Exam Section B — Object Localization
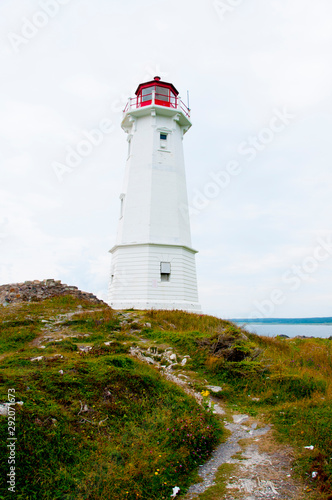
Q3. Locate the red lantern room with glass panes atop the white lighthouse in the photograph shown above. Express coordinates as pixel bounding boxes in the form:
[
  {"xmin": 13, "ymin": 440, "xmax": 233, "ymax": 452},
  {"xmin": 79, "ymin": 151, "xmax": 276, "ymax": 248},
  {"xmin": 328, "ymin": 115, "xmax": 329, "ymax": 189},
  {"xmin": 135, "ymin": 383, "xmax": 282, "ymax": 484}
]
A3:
[{"xmin": 135, "ymin": 76, "xmax": 179, "ymax": 108}]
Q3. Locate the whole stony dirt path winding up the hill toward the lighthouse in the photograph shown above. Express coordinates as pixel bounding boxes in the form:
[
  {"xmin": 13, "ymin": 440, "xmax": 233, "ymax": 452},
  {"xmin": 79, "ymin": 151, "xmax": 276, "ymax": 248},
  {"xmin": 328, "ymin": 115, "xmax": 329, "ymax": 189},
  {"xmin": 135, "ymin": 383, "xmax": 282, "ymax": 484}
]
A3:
[{"xmin": 131, "ymin": 342, "xmax": 317, "ymax": 500}]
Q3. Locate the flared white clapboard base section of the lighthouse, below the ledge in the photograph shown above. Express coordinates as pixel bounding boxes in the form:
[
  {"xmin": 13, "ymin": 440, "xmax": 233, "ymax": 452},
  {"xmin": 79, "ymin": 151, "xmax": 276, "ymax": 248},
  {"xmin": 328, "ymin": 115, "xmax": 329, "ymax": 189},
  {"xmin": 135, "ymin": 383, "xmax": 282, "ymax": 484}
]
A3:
[{"xmin": 108, "ymin": 243, "xmax": 201, "ymax": 312}]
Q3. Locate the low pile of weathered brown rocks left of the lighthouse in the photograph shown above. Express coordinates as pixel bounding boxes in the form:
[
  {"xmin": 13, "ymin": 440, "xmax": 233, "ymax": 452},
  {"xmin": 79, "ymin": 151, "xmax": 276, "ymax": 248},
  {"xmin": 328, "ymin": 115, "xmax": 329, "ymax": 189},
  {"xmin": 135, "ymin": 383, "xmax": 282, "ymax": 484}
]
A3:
[{"xmin": 0, "ymin": 279, "xmax": 105, "ymax": 305}]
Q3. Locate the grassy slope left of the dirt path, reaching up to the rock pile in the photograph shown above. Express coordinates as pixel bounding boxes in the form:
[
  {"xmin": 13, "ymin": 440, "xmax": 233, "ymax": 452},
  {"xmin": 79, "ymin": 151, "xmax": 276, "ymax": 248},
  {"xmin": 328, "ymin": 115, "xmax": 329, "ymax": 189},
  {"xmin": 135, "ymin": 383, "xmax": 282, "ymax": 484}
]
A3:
[{"xmin": 0, "ymin": 296, "xmax": 222, "ymax": 500}]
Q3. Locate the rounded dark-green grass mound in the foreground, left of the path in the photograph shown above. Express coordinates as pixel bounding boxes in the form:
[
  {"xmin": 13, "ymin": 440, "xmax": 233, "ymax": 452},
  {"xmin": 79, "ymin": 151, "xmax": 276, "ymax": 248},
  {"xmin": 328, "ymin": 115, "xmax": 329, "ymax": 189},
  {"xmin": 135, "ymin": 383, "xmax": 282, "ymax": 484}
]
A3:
[{"xmin": 1, "ymin": 355, "xmax": 223, "ymax": 499}]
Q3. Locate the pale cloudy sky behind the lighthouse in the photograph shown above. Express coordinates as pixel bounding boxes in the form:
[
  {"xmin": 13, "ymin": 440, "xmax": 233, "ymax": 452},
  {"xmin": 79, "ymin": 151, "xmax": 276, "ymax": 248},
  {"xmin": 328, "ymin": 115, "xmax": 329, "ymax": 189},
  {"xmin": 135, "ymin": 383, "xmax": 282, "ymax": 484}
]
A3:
[{"xmin": 0, "ymin": 0, "xmax": 332, "ymax": 318}]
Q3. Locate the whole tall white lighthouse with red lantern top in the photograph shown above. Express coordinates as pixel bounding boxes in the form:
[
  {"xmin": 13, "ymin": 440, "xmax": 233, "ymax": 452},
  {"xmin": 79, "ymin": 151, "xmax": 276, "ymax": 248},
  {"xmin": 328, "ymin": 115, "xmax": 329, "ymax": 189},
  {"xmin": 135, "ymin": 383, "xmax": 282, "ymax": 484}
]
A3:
[{"xmin": 109, "ymin": 76, "xmax": 200, "ymax": 312}]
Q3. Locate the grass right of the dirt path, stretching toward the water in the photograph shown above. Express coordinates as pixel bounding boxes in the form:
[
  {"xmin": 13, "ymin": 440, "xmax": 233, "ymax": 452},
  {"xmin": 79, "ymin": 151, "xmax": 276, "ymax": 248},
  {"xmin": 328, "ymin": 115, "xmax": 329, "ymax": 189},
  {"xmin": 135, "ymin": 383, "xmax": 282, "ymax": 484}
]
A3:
[{"xmin": 140, "ymin": 311, "xmax": 332, "ymax": 500}]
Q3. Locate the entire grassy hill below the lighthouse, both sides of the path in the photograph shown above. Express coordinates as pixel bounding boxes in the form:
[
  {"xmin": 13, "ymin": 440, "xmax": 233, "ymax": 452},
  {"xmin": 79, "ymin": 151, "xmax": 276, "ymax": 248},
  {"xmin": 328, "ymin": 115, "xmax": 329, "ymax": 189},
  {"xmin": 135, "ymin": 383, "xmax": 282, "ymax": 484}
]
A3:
[{"xmin": 0, "ymin": 295, "xmax": 332, "ymax": 500}]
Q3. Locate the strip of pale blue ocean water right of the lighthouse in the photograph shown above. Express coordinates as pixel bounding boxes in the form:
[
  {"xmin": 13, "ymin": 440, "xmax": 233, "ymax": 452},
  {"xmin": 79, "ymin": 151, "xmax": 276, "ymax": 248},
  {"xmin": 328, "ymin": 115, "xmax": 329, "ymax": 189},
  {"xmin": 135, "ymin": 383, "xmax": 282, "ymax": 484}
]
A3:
[{"xmin": 236, "ymin": 321, "xmax": 332, "ymax": 339}]
